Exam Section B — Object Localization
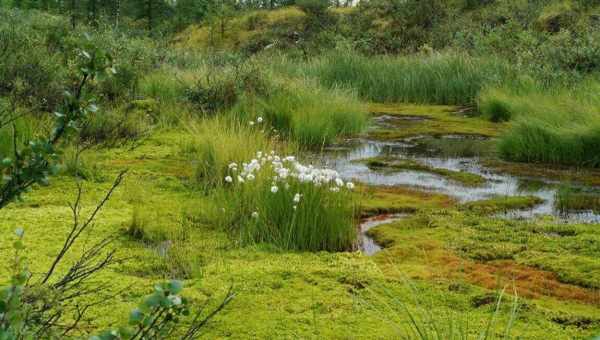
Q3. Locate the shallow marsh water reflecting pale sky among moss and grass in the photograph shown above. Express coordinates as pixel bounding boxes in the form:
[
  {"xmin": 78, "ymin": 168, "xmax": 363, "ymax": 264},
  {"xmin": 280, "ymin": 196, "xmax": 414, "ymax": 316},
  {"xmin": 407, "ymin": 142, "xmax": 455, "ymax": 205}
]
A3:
[{"xmin": 321, "ymin": 116, "xmax": 600, "ymax": 255}]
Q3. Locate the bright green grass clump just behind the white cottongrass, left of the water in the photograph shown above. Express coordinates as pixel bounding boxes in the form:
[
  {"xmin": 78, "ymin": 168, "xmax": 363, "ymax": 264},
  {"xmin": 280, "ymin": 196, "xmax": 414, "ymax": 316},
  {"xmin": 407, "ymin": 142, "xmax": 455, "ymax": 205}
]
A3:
[{"xmin": 232, "ymin": 80, "xmax": 368, "ymax": 148}]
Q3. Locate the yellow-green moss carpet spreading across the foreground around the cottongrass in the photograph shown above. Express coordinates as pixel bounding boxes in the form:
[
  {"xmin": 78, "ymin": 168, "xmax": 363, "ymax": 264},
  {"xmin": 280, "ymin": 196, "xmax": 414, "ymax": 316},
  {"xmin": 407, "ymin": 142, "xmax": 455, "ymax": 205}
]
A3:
[{"xmin": 0, "ymin": 116, "xmax": 600, "ymax": 338}]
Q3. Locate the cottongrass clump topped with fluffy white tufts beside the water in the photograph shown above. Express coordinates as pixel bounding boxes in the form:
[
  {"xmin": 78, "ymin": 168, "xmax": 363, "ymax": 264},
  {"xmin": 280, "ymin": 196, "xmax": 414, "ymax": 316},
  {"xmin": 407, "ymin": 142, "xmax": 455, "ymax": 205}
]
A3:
[{"xmin": 220, "ymin": 151, "xmax": 357, "ymax": 251}]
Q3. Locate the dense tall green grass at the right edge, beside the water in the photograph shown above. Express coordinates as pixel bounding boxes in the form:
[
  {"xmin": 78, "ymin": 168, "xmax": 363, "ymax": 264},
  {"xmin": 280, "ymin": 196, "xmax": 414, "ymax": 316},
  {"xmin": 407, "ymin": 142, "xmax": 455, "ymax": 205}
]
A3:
[{"xmin": 479, "ymin": 81, "xmax": 600, "ymax": 168}]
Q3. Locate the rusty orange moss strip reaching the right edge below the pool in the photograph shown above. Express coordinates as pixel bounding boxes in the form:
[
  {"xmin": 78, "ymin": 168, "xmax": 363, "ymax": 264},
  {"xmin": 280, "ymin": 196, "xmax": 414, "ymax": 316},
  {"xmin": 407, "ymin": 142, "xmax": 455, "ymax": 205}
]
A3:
[{"xmin": 379, "ymin": 239, "xmax": 600, "ymax": 305}]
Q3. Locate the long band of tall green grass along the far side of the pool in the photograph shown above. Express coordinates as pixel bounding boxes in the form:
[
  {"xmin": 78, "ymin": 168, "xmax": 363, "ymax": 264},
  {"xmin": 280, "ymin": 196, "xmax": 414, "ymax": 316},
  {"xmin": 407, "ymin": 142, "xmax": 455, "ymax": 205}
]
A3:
[{"xmin": 306, "ymin": 53, "xmax": 511, "ymax": 105}]
